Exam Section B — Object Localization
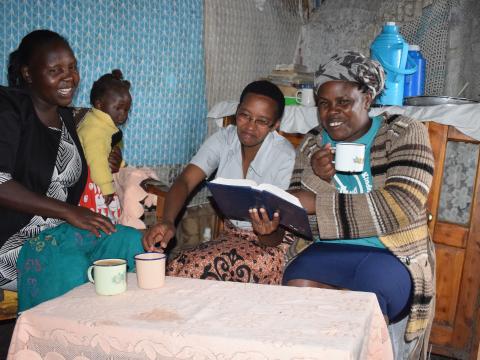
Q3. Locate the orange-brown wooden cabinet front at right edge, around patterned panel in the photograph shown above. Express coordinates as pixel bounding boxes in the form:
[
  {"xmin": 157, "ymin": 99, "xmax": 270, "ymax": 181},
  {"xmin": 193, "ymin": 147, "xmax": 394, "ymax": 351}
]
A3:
[{"xmin": 426, "ymin": 122, "xmax": 480, "ymax": 360}]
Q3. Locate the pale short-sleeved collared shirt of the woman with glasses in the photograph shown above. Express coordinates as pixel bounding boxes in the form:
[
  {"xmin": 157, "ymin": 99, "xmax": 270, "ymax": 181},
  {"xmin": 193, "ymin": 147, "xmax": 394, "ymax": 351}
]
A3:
[{"xmin": 190, "ymin": 125, "xmax": 295, "ymax": 228}]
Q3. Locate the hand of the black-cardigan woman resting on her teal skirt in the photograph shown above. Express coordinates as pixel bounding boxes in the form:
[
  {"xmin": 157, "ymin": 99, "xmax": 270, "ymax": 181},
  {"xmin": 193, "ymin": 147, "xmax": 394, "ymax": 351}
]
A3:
[{"xmin": 65, "ymin": 206, "xmax": 116, "ymax": 237}]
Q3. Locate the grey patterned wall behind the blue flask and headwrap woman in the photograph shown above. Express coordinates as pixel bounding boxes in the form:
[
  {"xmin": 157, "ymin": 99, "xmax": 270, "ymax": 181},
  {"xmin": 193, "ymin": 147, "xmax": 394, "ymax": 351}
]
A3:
[{"xmin": 301, "ymin": 0, "xmax": 452, "ymax": 95}]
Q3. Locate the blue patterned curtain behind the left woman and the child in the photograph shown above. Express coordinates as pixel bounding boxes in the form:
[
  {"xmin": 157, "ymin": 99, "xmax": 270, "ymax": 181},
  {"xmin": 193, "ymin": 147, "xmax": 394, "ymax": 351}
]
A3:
[{"xmin": 0, "ymin": 0, "xmax": 206, "ymax": 165}]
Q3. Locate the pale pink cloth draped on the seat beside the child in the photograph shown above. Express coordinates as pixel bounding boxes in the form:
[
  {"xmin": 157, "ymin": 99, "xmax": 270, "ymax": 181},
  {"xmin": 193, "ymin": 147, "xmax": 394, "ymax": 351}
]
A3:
[{"xmin": 113, "ymin": 166, "xmax": 158, "ymax": 229}]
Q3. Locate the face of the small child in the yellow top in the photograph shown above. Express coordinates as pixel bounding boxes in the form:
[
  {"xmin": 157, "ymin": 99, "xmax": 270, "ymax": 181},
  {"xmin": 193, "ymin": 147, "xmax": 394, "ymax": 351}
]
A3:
[{"xmin": 94, "ymin": 88, "xmax": 132, "ymax": 126}]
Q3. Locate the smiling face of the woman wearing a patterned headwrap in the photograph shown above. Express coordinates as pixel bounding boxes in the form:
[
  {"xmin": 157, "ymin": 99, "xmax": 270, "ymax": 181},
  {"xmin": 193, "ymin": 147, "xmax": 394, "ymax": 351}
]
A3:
[{"xmin": 317, "ymin": 81, "xmax": 372, "ymax": 141}]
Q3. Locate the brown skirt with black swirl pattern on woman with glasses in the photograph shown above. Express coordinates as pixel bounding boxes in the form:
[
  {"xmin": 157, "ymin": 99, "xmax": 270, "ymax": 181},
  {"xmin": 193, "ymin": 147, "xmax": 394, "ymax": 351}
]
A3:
[{"xmin": 167, "ymin": 222, "xmax": 292, "ymax": 285}]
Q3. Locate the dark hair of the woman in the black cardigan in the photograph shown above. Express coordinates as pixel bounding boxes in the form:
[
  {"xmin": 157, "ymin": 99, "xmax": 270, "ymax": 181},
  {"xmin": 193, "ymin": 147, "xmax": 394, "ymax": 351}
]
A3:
[{"xmin": 8, "ymin": 29, "xmax": 73, "ymax": 88}]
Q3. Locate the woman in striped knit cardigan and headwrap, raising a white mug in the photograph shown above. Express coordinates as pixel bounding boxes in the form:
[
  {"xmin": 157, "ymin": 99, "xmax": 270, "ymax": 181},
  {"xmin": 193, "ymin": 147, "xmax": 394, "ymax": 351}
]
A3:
[{"xmin": 252, "ymin": 51, "xmax": 435, "ymax": 359}]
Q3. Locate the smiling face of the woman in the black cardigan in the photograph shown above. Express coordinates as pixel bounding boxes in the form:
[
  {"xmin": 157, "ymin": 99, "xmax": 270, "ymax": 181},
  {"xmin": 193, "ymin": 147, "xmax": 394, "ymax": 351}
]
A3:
[{"xmin": 21, "ymin": 41, "xmax": 80, "ymax": 106}]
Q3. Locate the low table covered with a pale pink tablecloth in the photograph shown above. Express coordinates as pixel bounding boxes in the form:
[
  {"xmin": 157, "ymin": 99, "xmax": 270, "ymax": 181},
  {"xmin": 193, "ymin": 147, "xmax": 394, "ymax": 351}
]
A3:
[{"xmin": 8, "ymin": 274, "xmax": 393, "ymax": 360}]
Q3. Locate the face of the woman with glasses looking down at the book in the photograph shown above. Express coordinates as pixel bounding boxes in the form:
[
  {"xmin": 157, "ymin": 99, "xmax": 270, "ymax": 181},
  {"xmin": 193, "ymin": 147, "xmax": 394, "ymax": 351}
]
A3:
[{"xmin": 236, "ymin": 93, "xmax": 280, "ymax": 148}]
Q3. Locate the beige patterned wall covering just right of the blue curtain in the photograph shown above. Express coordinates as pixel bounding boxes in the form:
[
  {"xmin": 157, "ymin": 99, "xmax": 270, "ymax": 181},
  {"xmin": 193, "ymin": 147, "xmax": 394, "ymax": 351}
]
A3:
[{"xmin": 205, "ymin": 0, "xmax": 301, "ymax": 107}]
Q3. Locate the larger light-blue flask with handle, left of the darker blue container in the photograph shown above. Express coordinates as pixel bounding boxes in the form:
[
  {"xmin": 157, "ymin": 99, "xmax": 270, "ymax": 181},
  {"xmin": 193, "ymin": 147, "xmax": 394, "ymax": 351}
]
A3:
[{"xmin": 370, "ymin": 22, "xmax": 417, "ymax": 106}]
